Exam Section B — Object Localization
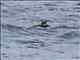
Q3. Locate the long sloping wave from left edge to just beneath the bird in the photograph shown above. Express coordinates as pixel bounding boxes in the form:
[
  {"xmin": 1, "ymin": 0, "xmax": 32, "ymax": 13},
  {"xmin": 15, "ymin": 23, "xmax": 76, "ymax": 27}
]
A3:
[{"xmin": 1, "ymin": 24, "xmax": 56, "ymax": 37}]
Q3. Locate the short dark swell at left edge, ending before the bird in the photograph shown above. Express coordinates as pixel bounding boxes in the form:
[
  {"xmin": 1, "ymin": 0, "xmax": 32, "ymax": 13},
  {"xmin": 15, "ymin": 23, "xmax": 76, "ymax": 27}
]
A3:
[{"xmin": 1, "ymin": 24, "xmax": 30, "ymax": 35}]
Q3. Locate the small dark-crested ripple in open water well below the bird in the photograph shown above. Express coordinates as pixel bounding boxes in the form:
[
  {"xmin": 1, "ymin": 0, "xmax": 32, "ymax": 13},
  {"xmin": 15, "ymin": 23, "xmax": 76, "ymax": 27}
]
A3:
[{"xmin": 15, "ymin": 40, "xmax": 45, "ymax": 49}]
